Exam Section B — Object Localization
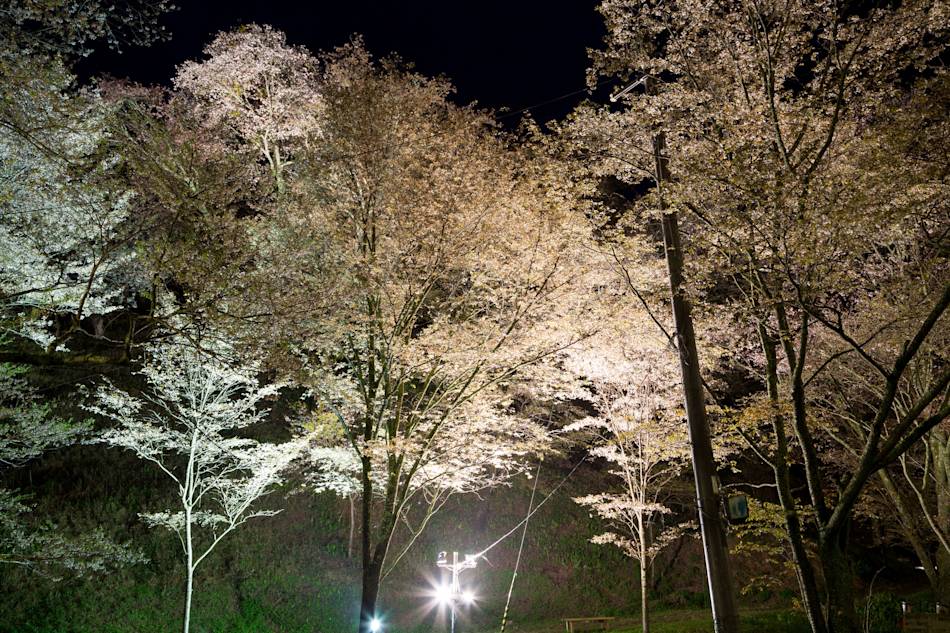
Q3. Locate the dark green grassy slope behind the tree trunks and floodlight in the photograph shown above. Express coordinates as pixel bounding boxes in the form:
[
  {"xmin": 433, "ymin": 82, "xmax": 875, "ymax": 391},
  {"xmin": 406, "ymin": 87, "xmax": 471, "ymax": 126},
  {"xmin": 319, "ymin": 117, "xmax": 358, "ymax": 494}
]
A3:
[{"xmin": 0, "ymin": 449, "xmax": 795, "ymax": 633}]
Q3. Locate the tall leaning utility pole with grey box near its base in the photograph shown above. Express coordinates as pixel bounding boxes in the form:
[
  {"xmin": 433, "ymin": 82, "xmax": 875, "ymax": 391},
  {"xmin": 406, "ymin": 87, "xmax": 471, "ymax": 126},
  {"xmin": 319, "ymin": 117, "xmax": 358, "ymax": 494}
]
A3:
[{"xmin": 641, "ymin": 84, "xmax": 739, "ymax": 633}]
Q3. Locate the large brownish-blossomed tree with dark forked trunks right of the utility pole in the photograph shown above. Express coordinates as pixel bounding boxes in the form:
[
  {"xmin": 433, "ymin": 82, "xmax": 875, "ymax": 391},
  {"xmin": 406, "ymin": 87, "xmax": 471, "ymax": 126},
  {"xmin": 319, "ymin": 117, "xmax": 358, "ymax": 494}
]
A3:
[{"xmin": 574, "ymin": 0, "xmax": 950, "ymax": 632}]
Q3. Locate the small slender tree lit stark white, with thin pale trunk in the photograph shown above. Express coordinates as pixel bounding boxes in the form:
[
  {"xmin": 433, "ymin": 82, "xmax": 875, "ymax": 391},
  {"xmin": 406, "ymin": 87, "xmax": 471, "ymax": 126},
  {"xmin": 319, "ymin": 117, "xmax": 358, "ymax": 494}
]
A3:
[{"xmin": 87, "ymin": 344, "xmax": 302, "ymax": 633}]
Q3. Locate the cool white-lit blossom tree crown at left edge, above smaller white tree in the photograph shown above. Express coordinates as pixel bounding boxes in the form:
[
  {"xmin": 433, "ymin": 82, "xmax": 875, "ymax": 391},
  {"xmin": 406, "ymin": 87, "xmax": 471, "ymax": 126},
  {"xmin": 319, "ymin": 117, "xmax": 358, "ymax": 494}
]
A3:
[{"xmin": 0, "ymin": 98, "xmax": 149, "ymax": 355}]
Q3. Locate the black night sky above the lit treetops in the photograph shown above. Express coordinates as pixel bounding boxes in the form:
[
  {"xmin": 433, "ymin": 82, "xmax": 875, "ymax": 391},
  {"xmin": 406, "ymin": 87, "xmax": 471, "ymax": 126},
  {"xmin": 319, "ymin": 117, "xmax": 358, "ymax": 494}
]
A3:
[{"xmin": 74, "ymin": 0, "xmax": 606, "ymax": 122}]
